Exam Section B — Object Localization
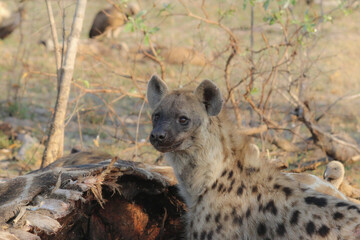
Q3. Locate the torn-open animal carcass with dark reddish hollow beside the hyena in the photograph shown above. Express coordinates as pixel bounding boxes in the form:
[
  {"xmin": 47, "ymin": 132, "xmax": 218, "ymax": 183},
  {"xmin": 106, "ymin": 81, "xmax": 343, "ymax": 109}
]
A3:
[{"xmin": 0, "ymin": 158, "xmax": 185, "ymax": 240}]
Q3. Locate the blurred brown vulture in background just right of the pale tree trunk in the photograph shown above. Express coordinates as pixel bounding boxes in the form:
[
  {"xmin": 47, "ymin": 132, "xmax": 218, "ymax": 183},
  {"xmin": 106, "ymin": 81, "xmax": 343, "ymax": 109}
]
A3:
[{"xmin": 89, "ymin": 3, "xmax": 140, "ymax": 38}]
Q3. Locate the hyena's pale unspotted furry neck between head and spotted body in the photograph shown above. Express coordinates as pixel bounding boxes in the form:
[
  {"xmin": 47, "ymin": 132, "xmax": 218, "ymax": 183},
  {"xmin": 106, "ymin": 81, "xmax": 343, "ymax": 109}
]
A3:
[{"xmin": 165, "ymin": 117, "xmax": 232, "ymax": 206}]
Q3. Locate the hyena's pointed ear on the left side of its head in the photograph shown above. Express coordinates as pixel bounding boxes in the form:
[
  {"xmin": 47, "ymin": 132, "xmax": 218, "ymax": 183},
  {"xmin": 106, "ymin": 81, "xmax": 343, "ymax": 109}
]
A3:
[{"xmin": 147, "ymin": 74, "xmax": 168, "ymax": 109}]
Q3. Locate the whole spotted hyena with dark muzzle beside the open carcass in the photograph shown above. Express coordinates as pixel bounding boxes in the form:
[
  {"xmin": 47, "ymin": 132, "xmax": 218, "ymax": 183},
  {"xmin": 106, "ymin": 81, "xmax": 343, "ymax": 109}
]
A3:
[{"xmin": 147, "ymin": 76, "xmax": 360, "ymax": 240}]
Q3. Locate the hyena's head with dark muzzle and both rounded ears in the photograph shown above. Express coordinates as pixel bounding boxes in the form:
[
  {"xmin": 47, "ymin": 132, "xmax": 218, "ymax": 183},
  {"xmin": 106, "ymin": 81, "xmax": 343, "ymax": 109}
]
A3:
[{"xmin": 147, "ymin": 75, "xmax": 222, "ymax": 152}]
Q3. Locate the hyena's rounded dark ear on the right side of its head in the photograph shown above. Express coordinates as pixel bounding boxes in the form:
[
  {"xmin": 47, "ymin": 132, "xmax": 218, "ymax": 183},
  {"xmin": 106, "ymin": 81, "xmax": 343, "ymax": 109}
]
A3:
[{"xmin": 195, "ymin": 80, "xmax": 223, "ymax": 116}]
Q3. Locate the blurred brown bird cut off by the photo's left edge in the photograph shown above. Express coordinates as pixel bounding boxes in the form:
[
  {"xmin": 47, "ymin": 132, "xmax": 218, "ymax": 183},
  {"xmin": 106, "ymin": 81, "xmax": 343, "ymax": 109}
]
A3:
[{"xmin": 0, "ymin": 2, "xmax": 26, "ymax": 39}]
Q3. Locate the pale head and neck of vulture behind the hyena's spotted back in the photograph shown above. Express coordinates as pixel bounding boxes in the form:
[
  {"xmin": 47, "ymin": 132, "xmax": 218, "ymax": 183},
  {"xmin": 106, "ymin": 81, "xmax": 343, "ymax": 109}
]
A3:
[{"xmin": 324, "ymin": 161, "xmax": 360, "ymax": 203}]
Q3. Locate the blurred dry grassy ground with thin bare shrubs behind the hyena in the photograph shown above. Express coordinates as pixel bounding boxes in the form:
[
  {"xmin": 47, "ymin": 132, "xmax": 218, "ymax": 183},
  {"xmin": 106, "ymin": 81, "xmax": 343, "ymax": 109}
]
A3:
[{"xmin": 0, "ymin": 0, "xmax": 360, "ymax": 187}]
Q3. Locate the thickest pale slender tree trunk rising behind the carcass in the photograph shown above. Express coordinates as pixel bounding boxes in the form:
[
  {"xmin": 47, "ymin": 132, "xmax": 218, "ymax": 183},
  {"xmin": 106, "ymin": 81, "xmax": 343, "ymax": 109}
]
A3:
[{"xmin": 41, "ymin": 0, "xmax": 87, "ymax": 168}]
